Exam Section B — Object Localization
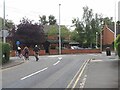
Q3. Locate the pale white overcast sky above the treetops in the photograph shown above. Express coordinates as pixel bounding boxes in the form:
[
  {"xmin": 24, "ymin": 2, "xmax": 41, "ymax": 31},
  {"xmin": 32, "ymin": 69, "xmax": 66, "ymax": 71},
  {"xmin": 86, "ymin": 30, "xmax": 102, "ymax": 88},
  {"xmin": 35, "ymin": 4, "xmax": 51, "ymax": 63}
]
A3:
[{"xmin": 0, "ymin": 0, "xmax": 119, "ymax": 26}]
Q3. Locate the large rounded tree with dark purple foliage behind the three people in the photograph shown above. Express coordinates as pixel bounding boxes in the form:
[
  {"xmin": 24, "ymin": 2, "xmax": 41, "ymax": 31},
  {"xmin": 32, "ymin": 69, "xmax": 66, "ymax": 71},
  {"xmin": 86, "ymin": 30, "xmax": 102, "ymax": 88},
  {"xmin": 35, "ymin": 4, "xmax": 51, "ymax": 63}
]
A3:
[{"xmin": 14, "ymin": 18, "xmax": 45, "ymax": 46}]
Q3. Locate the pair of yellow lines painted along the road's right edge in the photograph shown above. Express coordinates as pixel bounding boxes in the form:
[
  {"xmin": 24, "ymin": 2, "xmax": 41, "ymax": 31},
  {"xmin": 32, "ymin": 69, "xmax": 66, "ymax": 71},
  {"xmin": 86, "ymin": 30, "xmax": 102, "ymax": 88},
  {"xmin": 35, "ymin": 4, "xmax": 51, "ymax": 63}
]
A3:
[{"xmin": 66, "ymin": 59, "xmax": 91, "ymax": 90}]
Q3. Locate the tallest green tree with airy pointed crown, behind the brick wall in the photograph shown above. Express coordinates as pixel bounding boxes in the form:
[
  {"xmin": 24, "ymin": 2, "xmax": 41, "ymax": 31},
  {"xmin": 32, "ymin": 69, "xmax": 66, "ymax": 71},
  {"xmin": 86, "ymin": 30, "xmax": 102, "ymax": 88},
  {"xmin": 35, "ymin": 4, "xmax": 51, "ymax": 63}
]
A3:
[{"xmin": 72, "ymin": 6, "xmax": 102, "ymax": 48}]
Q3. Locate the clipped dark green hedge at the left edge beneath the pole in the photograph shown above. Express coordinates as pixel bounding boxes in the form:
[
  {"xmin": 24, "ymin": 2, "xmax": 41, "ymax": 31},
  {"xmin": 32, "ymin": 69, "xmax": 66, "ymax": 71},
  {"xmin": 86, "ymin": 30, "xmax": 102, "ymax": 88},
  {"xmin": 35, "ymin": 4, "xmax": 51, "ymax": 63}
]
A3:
[{"xmin": 0, "ymin": 43, "xmax": 10, "ymax": 64}]
